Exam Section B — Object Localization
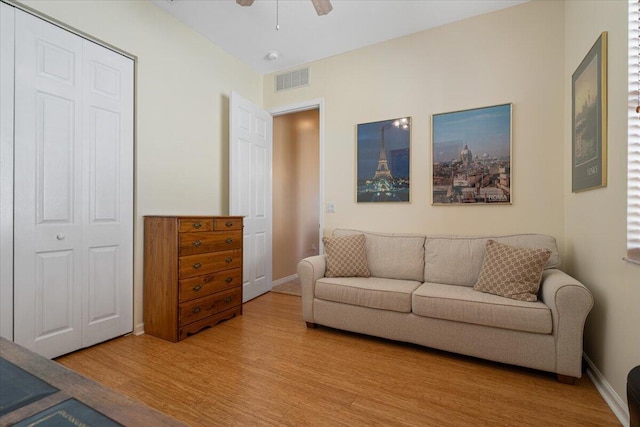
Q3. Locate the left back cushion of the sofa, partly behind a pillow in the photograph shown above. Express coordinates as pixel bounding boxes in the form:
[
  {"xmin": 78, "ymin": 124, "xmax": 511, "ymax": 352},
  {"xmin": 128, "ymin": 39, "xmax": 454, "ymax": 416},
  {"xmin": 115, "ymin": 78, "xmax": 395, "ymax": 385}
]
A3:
[{"xmin": 333, "ymin": 229, "xmax": 425, "ymax": 282}]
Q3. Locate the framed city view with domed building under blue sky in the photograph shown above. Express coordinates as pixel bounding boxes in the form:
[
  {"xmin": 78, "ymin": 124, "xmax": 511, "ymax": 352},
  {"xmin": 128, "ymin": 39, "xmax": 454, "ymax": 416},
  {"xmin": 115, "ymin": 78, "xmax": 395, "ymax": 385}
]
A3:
[{"xmin": 431, "ymin": 104, "xmax": 512, "ymax": 205}]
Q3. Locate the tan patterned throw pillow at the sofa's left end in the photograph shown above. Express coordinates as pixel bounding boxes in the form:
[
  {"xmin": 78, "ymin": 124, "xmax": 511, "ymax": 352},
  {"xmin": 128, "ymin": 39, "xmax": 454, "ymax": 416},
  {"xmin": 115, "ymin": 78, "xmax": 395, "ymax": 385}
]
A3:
[{"xmin": 322, "ymin": 234, "xmax": 371, "ymax": 277}]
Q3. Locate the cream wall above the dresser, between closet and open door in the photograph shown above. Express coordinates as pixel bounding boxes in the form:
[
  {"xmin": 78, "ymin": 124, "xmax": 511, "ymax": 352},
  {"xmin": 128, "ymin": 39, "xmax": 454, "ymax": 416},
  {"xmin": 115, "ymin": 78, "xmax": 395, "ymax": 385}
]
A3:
[{"xmin": 16, "ymin": 0, "xmax": 262, "ymax": 327}]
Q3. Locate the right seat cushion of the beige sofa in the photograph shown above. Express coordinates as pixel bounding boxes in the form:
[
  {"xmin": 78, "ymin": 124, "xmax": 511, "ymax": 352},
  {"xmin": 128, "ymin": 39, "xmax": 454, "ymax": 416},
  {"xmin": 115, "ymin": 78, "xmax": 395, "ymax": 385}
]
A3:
[{"xmin": 413, "ymin": 282, "xmax": 552, "ymax": 334}]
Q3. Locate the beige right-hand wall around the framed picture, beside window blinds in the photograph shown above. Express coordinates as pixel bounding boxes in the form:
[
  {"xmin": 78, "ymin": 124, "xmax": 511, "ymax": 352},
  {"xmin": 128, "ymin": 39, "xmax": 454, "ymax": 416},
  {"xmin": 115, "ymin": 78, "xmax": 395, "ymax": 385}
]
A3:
[{"xmin": 564, "ymin": 0, "xmax": 640, "ymax": 402}]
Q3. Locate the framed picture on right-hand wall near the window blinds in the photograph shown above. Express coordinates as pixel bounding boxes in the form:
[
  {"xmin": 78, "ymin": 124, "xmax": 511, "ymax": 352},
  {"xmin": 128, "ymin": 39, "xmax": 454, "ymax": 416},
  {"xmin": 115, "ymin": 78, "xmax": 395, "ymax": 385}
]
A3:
[{"xmin": 571, "ymin": 32, "xmax": 607, "ymax": 193}]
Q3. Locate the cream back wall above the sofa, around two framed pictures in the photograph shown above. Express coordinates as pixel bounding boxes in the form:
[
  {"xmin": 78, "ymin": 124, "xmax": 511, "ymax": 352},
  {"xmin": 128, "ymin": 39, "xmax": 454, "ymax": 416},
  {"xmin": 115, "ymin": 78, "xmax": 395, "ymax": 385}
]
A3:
[{"xmin": 264, "ymin": 1, "xmax": 564, "ymax": 244}]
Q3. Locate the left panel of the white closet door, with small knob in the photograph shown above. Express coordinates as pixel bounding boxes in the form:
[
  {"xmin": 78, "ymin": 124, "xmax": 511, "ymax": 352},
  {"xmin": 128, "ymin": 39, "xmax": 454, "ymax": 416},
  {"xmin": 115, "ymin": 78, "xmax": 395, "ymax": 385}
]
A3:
[{"xmin": 14, "ymin": 11, "xmax": 82, "ymax": 357}]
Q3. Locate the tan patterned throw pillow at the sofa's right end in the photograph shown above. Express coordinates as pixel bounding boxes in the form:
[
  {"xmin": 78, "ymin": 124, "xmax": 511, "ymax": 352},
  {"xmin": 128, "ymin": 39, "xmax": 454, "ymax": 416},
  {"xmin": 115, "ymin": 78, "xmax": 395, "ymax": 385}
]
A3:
[{"xmin": 473, "ymin": 240, "xmax": 551, "ymax": 302}]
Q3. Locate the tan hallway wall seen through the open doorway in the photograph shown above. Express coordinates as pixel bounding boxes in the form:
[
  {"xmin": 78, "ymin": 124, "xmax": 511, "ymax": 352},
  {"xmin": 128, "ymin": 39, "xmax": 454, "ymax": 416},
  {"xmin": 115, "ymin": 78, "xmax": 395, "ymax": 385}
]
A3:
[{"xmin": 273, "ymin": 110, "xmax": 320, "ymax": 280}]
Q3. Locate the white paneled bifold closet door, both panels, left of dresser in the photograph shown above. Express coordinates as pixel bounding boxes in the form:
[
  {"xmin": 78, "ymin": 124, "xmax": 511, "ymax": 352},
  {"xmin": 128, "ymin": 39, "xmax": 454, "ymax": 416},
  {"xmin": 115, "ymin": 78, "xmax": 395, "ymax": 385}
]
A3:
[{"xmin": 14, "ymin": 10, "xmax": 133, "ymax": 357}]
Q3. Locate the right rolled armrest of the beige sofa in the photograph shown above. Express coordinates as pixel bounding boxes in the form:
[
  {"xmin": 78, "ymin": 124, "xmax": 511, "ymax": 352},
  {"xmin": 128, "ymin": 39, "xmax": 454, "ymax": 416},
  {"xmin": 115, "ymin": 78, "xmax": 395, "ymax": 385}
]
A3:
[{"xmin": 540, "ymin": 269, "xmax": 593, "ymax": 378}]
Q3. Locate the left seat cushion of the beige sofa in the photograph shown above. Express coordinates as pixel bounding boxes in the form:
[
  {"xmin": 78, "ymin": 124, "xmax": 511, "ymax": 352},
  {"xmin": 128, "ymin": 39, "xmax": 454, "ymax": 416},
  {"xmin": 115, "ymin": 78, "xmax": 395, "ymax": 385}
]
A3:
[{"xmin": 315, "ymin": 277, "xmax": 421, "ymax": 313}]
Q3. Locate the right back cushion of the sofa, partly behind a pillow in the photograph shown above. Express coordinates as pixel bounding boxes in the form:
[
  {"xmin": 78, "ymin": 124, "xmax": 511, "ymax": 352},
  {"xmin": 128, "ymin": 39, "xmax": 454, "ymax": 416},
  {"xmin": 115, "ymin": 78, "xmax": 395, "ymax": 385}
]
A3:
[{"xmin": 424, "ymin": 234, "xmax": 560, "ymax": 286}]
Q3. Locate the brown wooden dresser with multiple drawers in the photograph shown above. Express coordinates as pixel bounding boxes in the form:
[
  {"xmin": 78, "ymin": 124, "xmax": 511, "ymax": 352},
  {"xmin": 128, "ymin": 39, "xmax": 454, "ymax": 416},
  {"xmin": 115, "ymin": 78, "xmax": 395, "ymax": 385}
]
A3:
[{"xmin": 144, "ymin": 216, "xmax": 243, "ymax": 342}]
